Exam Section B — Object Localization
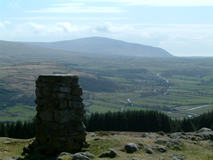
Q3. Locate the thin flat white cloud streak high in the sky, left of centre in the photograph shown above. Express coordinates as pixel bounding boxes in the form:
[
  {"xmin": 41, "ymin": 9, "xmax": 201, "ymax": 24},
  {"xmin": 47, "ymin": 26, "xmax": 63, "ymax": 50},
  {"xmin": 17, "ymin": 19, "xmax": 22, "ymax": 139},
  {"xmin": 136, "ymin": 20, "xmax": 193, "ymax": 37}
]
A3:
[{"xmin": 25, "ymin": 3, "xmax": 124, "ymax": 13}]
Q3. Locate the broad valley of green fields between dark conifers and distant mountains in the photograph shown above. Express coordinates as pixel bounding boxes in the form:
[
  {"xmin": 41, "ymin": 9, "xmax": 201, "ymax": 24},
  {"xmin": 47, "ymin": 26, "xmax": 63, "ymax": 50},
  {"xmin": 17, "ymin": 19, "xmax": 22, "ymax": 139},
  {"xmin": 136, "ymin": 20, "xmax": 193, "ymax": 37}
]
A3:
[{"xmin": 0, "ymin": 53, "xmax": 213, "ymax": 121}]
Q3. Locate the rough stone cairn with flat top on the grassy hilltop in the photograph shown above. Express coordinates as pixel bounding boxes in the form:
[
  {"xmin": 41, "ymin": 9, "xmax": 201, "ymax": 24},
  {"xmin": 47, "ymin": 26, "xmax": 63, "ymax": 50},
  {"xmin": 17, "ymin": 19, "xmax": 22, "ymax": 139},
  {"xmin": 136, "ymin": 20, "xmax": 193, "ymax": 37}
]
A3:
[{"xmin": 23, "ymin": 74, "xmax": 87, "ymax": 154}]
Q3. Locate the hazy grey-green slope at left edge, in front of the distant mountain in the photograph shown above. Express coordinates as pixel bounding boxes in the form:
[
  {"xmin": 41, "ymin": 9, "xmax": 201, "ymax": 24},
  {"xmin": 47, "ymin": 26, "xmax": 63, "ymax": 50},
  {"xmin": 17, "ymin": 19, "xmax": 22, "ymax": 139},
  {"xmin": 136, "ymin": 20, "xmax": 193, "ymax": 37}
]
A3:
[{"xmin": 0, "ymin": 40, "xmax": 78, "ymax": 64}]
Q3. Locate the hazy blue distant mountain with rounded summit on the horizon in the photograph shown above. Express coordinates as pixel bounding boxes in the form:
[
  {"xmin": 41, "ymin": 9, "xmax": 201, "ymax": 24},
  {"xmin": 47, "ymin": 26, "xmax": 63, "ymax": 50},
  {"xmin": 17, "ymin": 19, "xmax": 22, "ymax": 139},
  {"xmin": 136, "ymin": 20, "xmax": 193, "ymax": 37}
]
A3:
[{"xmin": 22, "ymin": 37, "xmax": 173, "ymax": 57}]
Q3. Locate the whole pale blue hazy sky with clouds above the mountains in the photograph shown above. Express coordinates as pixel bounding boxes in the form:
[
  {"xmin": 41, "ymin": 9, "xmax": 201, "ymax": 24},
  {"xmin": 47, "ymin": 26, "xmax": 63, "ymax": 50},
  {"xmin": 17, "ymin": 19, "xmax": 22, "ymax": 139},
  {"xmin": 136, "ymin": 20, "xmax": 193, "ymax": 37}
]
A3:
[{"xmin": 0, "ymin": 0, "xmax": 213, "ymax": 56}]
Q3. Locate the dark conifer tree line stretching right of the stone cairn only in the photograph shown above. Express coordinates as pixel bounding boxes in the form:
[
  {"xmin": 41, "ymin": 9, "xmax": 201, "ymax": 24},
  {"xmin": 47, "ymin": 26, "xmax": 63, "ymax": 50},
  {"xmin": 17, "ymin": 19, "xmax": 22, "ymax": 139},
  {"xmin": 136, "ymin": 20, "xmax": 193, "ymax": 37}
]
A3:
[{"xmin": 85, "ymin": 110, "xmax": 213, "ymax": 133}]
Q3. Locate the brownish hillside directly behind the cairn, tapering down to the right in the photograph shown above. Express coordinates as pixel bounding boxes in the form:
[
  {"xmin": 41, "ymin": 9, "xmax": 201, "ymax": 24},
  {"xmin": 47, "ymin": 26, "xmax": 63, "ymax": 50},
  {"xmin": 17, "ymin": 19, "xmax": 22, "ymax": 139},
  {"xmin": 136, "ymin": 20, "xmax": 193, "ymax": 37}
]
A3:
[{"xmin": 0, "ymin": 62, "xmax": 123, "ymax": 121}]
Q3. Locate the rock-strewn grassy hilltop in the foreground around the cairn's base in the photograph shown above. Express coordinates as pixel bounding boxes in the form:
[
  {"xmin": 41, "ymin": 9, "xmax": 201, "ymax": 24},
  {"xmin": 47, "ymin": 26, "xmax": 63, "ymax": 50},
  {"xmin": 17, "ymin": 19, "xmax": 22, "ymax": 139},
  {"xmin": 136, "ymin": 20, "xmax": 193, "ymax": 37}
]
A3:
[{"xmin": 0, "ymin": 131, "xmax": 213, "ymax": 160}]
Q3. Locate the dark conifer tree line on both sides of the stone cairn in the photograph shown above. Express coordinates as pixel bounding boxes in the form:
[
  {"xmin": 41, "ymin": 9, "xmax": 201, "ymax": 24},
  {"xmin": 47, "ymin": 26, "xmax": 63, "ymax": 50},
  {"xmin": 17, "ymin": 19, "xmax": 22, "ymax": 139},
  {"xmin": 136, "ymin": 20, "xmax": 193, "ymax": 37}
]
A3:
[{"xmin": 0, "ymin": 110, "xmax": 213, "ymax": 139}]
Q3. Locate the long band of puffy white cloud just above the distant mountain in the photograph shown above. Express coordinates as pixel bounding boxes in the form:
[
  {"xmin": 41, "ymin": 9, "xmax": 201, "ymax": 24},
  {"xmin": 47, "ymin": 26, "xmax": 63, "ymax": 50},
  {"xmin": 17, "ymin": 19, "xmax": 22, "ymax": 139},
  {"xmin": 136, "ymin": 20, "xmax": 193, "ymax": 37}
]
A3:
[{"xmin": 13, "ymin": 22, "xmax": 213, "ymax": 43}]
